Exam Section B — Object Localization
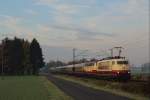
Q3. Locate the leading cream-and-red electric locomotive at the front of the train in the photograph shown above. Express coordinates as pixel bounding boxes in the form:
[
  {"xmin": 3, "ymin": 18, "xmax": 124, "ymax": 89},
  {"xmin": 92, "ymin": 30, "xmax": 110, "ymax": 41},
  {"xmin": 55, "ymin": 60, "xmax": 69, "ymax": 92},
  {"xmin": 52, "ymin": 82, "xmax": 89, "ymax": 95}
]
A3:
[{"xmin": 97, "ymin": 57, "xmax": 130, "ymax": 80}]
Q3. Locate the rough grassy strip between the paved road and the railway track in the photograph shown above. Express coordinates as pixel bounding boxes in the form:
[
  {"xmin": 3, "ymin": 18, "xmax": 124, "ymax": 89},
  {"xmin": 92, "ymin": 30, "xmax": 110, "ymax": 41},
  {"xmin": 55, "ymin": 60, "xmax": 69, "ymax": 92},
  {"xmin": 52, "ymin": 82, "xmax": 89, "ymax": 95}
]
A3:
[{"xmin": 55, "ymin": 75, "xmax": 150, "ymax": 100}]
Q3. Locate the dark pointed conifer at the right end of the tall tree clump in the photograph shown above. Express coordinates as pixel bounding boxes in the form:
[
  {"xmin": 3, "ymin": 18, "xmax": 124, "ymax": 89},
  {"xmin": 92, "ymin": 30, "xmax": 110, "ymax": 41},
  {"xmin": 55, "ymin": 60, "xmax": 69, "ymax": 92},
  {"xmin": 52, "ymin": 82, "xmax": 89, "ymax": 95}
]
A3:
[{"xmin": 30, "ymin": 39, "xmax": 44, "ymax": 74}]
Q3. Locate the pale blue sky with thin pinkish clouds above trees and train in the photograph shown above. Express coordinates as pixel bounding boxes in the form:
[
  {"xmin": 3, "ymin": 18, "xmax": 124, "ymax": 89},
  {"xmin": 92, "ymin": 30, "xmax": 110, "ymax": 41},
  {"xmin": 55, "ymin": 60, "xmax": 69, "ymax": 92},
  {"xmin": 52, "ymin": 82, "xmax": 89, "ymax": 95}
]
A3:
[{"xmin": 0, "ymin": 0, "xmax": 149, "ymax": 64}]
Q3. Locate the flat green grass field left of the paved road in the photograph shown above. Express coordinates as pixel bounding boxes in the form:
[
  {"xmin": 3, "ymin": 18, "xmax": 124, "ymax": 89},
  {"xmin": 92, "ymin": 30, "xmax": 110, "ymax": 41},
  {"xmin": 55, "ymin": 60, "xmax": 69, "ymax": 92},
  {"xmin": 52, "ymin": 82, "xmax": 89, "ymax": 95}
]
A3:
[{"xmin": 0, "ymin": 76, "xmax": 71, "ymax": 100}]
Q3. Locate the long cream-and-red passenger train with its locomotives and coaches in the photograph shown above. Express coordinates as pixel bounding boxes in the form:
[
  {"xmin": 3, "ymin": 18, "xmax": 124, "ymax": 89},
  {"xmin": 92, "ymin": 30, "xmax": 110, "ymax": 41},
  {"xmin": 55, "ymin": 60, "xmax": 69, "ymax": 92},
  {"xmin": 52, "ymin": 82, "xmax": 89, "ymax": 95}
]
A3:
[{"xmin": 52, "ymin": 57, "xmax": 130, "ymax": 80}]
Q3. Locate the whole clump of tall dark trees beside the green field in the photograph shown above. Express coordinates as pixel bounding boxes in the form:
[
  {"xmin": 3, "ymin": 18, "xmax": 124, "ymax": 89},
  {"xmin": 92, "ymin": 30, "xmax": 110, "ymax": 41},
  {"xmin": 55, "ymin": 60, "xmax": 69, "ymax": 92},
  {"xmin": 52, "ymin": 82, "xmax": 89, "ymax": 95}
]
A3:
[{"xmin": 0, "ymin": 37, "xmax": 44, "ymax": 75}]
